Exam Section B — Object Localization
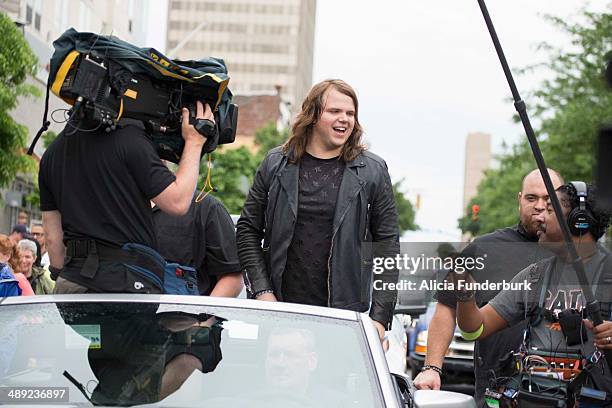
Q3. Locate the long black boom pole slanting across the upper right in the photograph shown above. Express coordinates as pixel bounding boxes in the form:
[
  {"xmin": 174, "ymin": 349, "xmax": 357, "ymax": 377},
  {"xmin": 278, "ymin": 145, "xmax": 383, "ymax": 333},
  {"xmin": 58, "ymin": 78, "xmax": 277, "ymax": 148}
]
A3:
[{"xmin": 478, "ymin": 0, "xmax": 612, "ymax": 370}]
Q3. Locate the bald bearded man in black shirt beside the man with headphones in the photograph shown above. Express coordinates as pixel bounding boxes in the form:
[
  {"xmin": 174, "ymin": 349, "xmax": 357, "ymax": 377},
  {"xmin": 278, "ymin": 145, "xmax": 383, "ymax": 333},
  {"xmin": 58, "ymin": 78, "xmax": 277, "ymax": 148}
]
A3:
[{"xmin": 414, "ymin": 169, "xmax": 564, "ymax": 407}]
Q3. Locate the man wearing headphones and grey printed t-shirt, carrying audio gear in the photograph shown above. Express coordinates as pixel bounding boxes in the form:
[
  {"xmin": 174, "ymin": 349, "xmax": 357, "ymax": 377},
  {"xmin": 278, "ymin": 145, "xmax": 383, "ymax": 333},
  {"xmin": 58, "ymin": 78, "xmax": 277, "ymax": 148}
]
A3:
[{"xmin": 453, "ymin": 182, "xmax": 612, "ymax": 403}]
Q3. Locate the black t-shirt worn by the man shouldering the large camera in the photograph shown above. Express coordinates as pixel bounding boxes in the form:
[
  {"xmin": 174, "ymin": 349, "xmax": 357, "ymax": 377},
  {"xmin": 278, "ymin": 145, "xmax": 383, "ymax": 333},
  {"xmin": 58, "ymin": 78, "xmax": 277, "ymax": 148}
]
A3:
[{"xmin": 38, "ymin": 122, "xmax": 175, "ymax": 248}]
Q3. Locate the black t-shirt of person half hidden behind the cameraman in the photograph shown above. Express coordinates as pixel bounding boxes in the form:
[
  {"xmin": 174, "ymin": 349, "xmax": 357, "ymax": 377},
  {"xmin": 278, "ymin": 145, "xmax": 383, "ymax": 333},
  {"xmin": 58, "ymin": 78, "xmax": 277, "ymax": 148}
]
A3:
[{"xmin": 153, "ymin": 195, "xmax": 240, "ymax": 295}]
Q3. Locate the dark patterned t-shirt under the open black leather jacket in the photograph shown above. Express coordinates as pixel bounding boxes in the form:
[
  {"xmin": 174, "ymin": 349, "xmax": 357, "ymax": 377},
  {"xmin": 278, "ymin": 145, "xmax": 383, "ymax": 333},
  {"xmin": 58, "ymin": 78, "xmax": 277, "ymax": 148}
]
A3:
[{"xmin": 282, "ymin": 153, "xmax": 344, "ymax": 306}]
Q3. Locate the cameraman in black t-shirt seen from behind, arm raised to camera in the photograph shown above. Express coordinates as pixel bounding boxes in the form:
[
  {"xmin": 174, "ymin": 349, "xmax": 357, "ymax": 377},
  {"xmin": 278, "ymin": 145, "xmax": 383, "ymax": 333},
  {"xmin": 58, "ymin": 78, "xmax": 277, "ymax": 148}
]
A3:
[{"xmin": 39, "ymin": 102, "xmax": 214, "ymax": 293}]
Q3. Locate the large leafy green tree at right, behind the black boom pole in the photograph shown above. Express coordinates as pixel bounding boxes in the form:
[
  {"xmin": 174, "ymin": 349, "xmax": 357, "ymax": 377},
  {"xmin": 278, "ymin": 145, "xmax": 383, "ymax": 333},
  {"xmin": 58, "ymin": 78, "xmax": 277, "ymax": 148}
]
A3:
[{"xmin": 459, "ymin": 6, "xmax": 612, "ymax": 234}]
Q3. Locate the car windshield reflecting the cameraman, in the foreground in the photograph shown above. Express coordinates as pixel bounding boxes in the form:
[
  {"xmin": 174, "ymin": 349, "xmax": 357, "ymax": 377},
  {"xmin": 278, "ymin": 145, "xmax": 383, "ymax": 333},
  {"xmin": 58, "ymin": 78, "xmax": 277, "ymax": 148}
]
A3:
[{"xmin": 0, "ymin": 302, "xmax": 382, "ymax": 407}]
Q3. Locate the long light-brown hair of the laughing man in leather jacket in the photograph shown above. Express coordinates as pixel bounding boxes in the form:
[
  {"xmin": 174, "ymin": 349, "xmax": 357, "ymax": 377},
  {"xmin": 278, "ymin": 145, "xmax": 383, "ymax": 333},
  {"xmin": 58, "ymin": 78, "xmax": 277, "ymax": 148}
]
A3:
[{"xmin": 283, "ymin": 79, "xmax": 365, "ymax": 163}]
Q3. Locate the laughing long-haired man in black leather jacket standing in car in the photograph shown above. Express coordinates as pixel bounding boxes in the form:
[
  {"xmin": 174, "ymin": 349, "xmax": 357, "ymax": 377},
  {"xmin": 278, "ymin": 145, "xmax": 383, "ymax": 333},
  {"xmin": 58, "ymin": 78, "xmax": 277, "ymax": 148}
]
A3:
[{"xmin": 237, "ymin": 79, "xmax": 399, "ymax": 339}]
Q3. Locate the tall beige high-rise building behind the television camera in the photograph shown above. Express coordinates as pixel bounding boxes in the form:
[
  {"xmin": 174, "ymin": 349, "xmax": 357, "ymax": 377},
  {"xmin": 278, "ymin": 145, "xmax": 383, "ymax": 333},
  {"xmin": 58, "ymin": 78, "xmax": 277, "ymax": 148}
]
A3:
[{"xmin": 166, "ymin": 0, "xmax": 316, "ymax": 113}]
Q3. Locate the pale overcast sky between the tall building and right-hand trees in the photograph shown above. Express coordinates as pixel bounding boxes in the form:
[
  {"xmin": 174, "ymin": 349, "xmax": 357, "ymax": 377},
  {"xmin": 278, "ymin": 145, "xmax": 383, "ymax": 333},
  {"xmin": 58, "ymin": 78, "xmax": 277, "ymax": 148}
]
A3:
[{"xmin": 150, "ymin": 0, "xmax": 610, "ymax": 237}]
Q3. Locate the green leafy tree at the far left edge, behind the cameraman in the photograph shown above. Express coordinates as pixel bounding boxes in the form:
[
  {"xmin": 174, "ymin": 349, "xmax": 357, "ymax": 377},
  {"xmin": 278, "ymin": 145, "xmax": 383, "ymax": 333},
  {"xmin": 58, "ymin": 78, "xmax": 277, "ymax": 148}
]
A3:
[{"xmin": 0, "ymin": 13, "xmax": 39, "ymax": 187}]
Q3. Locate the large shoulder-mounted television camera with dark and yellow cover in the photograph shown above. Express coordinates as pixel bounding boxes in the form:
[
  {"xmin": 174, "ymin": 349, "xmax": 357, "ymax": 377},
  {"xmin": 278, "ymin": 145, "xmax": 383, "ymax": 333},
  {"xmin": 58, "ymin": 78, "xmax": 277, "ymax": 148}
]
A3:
[{"xmin": 30, "ymin": 29, "xmax": 238, "ymax": 163}]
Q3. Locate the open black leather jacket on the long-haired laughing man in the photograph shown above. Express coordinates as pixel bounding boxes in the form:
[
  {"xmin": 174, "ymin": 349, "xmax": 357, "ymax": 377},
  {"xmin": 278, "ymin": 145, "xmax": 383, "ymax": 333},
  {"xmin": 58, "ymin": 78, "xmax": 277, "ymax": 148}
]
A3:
[{"xmin": 236, "ymin": 147, "xmax": 399, "ymax": 326}]
